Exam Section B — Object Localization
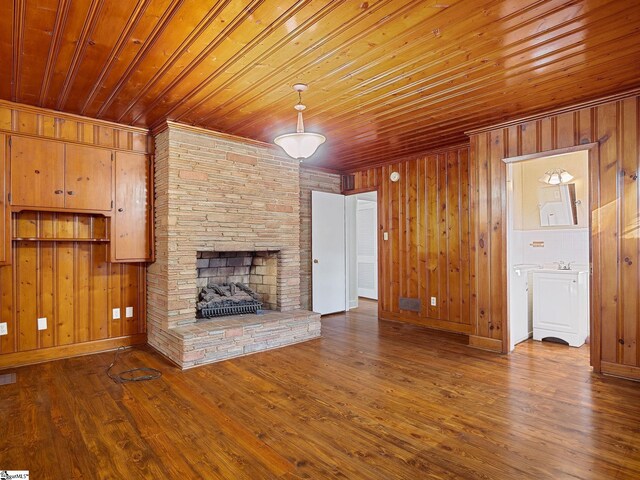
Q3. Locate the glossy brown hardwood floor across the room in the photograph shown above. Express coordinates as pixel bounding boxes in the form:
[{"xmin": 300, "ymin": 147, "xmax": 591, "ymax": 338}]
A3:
[{"xmin": 0, "ymin": 302, "xmax": 640, "ymax": 479}]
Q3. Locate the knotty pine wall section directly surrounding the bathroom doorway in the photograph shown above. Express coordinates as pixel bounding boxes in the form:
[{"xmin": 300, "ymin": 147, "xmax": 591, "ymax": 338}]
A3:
[{"xmin": 471, "ymin": 96, "xmax": 640, "ymax": 370}]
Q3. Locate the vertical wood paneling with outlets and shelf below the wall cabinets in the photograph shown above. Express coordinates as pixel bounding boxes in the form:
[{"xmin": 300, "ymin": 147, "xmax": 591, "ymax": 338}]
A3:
[{"xmin": 0, "ymin": 212, "xmax": 146, "ymax": 358}]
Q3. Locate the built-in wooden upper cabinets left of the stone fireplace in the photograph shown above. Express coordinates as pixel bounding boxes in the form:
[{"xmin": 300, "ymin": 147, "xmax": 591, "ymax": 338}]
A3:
[{"xmin": 6, "ymin": 136, "xmax": 153, "ymax": 262}]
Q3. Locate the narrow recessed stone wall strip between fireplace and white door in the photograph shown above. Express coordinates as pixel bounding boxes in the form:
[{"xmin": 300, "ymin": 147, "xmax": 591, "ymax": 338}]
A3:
[{"xmin": 300, "ymin": 167, "xmax": 341, "ymax": 310}]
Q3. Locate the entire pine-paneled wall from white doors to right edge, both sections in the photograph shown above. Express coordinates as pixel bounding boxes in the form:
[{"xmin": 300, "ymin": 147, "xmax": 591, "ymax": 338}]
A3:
[{"xmin": 346, "ymin": 96, "xmax": 640, "ymax": 378}]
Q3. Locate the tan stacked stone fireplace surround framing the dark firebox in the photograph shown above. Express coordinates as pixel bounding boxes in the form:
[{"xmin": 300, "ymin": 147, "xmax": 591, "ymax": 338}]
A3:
[{"xmin": 147, "ymin": 122, "xmax": 320, "ymax": 365}]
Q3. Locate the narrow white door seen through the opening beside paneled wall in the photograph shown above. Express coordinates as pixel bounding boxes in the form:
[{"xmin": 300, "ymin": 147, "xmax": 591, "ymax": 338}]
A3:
[{"xmin": 356, "ymin": 200, "xmax": 378, "ymax": 300}]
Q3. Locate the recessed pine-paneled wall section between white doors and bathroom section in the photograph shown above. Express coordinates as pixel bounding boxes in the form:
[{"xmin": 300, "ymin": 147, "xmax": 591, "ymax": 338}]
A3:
[{"xmin": 354, "ymin": 146, "xmax": 472, "ymax": 333}]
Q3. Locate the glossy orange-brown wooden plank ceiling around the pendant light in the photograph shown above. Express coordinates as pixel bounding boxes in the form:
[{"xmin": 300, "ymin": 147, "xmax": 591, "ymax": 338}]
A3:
[{"xmin": 0, "ymin": 0, "xmax": 640, "ymax": 171}]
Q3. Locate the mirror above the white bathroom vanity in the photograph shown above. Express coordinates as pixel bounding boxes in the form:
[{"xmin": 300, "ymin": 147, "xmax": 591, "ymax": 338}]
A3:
[{"xmin": 538, "ymin": 183, "xmax": 578, "ymax": 227}]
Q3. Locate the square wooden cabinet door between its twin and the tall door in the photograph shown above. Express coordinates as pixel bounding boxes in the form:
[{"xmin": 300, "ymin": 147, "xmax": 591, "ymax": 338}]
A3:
[{"xmin": 64, "ymin": 145, "xmax": 112, "ymax": 211}]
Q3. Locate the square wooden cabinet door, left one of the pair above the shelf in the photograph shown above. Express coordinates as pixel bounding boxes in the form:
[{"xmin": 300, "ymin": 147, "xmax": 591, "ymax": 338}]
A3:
[{"xmin": 11, "ymin": 137, "xmax": 64, "ymax": 208}]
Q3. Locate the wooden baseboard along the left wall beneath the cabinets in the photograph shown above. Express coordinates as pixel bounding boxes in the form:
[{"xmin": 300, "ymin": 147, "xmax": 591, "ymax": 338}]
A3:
[{"xmin": 0, "ymin": 333, "xmax": 147, "ymax": 369}]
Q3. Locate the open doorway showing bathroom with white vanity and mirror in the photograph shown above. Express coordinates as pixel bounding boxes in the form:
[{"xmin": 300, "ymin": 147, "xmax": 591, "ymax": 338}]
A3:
[{"xmin": 505, "ymin": 150, "xmax": 591, "ymax": 364}]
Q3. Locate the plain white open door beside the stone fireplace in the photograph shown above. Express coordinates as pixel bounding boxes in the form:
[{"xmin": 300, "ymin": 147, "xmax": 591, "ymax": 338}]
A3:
[{"xmin": 311, "ymin": 192, "xmax": 347, "ymax": 315}]
